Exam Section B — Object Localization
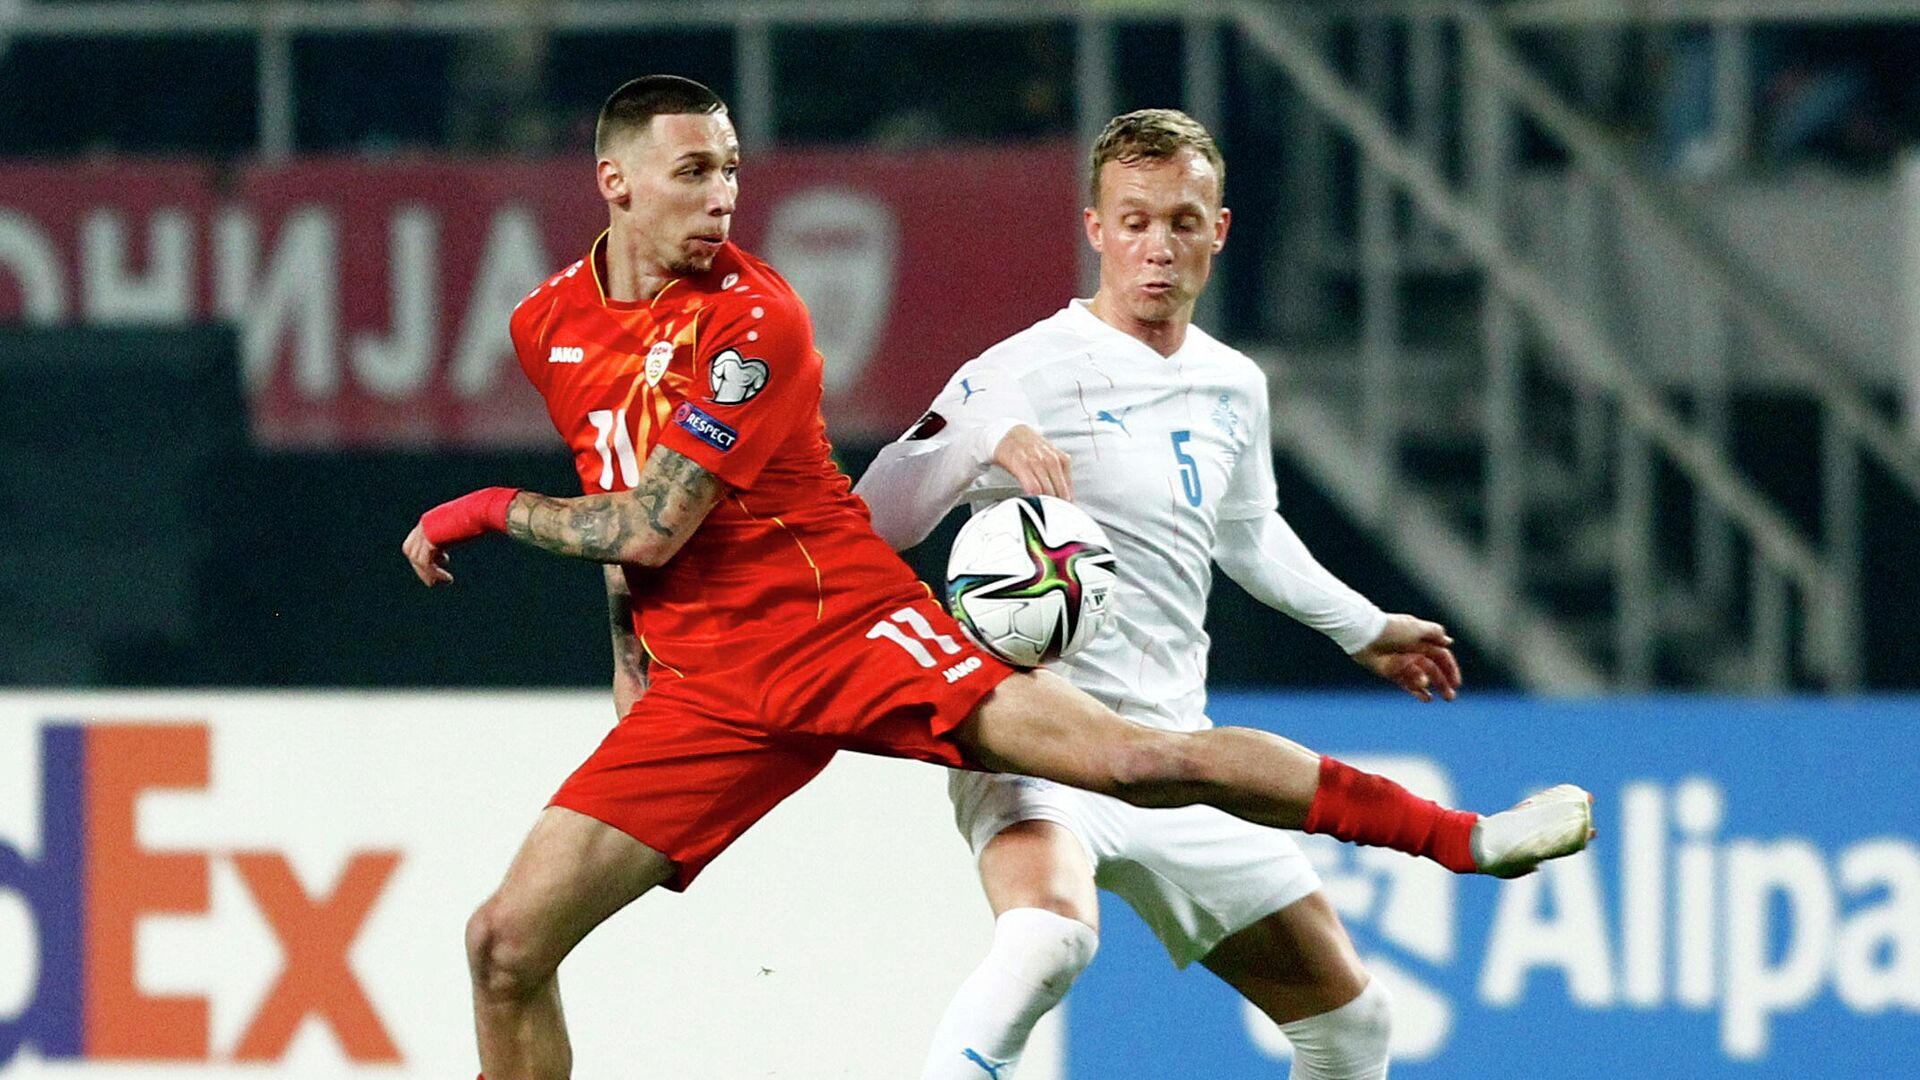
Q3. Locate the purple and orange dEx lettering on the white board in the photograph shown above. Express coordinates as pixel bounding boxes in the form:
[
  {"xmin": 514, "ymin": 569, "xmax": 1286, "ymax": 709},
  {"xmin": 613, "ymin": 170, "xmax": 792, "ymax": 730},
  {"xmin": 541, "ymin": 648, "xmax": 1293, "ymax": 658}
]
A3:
[{"xmin": 0, "ymin": 724, "xmax": 399, "ymax": 1070}]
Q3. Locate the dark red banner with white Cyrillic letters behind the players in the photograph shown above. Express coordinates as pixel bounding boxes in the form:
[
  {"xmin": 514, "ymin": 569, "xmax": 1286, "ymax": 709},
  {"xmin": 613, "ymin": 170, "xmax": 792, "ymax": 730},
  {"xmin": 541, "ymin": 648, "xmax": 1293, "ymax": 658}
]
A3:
[{"xmin": 0, "ymin": 142, "xmax": 1081, "ymax": 448}]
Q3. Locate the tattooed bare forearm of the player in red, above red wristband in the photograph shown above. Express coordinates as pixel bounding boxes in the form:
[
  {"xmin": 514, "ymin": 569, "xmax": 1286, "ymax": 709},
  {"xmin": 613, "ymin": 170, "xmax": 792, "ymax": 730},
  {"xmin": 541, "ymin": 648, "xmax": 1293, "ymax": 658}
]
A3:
[{"xmin": 507, "ymin": 446, "xmax": 722, "ymax": 563}]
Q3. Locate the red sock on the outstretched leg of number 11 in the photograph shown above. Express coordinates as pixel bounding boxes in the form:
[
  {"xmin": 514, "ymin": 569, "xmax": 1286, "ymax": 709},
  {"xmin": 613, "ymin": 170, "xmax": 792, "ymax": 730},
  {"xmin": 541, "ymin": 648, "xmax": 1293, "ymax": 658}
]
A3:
[{"xmin": 1304, "ymin": 755, "xmax": 1478, "ymax": 874}]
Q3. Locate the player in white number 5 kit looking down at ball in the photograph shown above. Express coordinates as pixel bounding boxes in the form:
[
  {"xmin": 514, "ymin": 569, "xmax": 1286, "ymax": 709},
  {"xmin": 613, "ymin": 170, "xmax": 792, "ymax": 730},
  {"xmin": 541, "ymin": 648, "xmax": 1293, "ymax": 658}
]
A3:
[{"xmin": 856, "ymin": 110, "xmax": 1459, "ymax": 1080}]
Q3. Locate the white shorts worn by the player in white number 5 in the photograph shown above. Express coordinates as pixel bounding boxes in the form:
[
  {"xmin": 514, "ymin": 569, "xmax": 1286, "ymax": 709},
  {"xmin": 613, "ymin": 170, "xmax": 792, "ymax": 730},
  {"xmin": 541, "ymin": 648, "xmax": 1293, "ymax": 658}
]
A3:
[{"xmin": 947, "ymin": 771, "xmax": 1321, "ymax": 967}]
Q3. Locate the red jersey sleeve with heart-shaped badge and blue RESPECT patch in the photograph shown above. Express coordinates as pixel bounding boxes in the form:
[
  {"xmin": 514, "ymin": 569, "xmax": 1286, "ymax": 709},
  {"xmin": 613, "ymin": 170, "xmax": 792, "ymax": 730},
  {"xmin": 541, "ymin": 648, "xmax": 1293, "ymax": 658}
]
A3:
[{"xmin": 660, "ymin": 294, "xmax": 820, "ymax": 488}]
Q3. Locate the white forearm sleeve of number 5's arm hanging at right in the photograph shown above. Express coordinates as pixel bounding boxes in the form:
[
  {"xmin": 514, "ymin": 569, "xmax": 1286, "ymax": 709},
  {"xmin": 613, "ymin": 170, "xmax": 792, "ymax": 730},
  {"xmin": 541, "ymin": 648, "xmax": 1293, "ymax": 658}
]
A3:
[{"xmin": 1213, "ymin": 513, "xmax": 1386, "ymax": 653}]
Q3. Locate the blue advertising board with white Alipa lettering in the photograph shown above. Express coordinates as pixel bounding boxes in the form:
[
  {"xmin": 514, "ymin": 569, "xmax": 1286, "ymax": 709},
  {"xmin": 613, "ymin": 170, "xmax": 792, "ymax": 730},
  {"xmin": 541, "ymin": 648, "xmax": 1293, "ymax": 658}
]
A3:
[{"xmin": 1068, "ymin": 694, "xmax": 1920, "ymax": 1080}]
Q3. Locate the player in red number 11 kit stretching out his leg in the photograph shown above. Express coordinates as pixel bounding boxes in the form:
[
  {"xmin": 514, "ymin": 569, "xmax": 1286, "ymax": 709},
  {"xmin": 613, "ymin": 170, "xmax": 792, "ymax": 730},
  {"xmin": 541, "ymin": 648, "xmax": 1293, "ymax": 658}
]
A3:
[{"xmin": 403, "ymin": 75, "xmax": 1590, "ymax": 1080}]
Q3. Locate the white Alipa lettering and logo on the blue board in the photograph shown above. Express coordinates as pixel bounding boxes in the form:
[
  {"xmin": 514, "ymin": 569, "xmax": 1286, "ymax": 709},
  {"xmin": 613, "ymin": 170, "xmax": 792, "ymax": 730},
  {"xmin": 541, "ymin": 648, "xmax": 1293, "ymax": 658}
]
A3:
[{"xmin": 1246, "ymin": 757, "xmax": 1920, "ymax": 1061}]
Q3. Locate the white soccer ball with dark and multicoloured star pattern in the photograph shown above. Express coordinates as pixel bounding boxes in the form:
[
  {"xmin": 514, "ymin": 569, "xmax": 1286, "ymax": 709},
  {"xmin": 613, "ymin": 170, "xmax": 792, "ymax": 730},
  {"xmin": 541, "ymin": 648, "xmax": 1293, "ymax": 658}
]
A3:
[{"xmin": 947, "ymin": 496, "xmax": 1114, "ymax": 667}]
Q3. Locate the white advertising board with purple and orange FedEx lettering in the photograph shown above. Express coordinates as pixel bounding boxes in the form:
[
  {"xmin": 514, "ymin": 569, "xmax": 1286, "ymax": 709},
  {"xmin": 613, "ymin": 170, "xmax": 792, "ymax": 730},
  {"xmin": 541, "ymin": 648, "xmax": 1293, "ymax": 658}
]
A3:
[{"xmin": 0, "ymin": 692, "xmax": 1058, "ymax": 1080}]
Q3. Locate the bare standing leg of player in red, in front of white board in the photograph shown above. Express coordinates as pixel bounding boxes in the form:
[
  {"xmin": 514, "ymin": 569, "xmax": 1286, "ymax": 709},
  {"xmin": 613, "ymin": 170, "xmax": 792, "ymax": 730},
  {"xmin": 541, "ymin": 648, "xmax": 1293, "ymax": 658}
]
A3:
[{"xmin": 467, "ymin": 807, "xmax": 674, "ymax": 1080}]
